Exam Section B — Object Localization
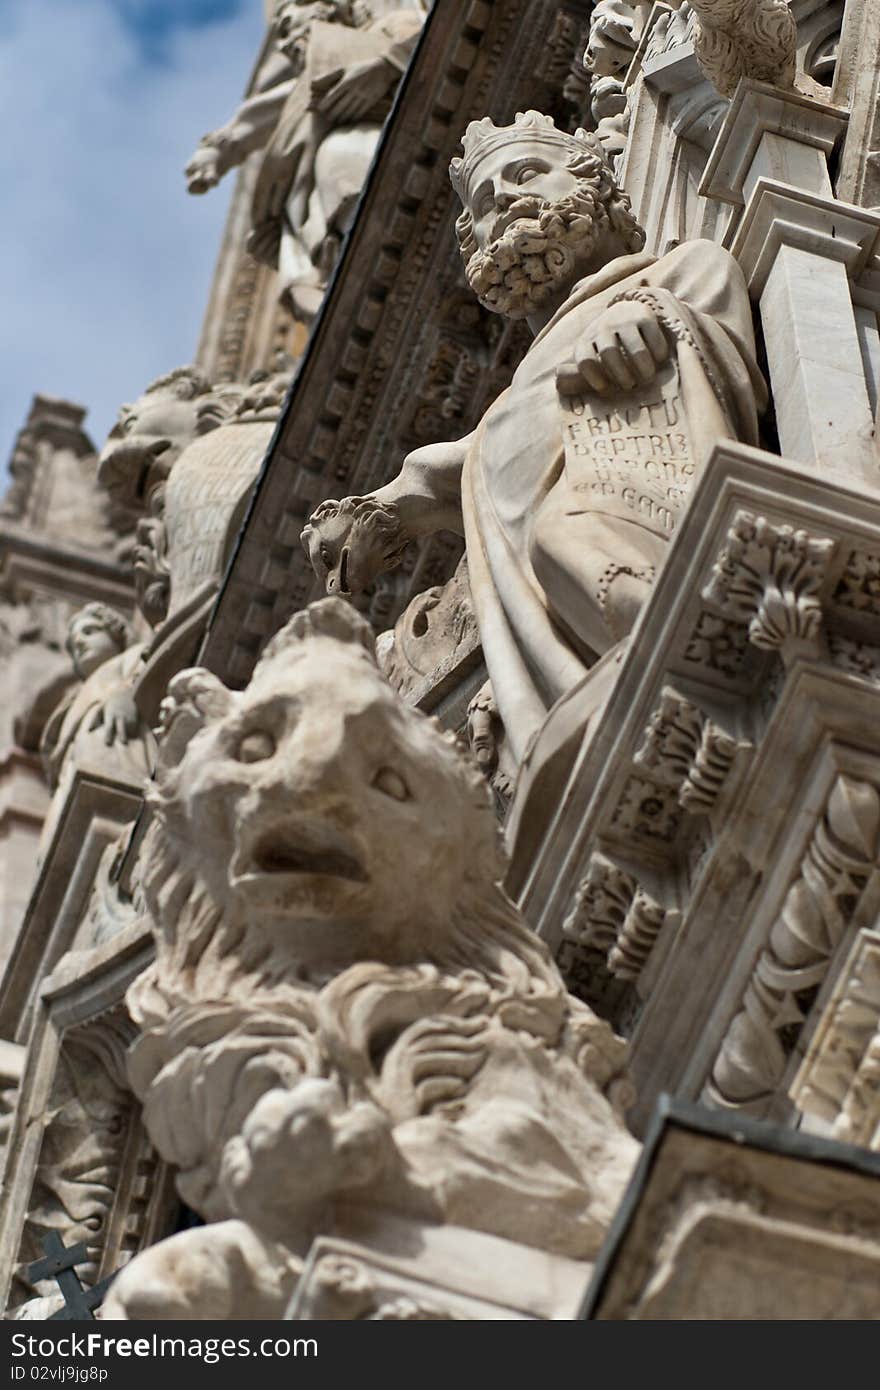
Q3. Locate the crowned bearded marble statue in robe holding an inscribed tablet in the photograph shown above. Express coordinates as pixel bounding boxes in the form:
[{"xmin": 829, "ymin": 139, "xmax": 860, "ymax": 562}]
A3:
[{"xmin": 303, "ymin": 111, "xmax": 765, "ymax": 762}]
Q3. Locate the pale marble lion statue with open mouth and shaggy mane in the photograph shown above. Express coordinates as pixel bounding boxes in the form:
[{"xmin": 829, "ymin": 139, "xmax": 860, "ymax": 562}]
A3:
[{"xmin": 103, "ymin": 598, "xmax": 638, "ymax": 1319}]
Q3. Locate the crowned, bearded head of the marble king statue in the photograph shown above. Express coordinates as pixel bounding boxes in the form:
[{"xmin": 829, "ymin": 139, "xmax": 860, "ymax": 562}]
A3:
[{"xmin": 449, "ymin": 111, "xmax": 645, "ymax": 318}]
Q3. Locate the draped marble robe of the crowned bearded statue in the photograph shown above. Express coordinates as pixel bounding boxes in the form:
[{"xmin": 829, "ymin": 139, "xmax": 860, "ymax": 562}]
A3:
[{"xmin": 378, "ymin": 240, "xmax": 765, "ymax": 760}]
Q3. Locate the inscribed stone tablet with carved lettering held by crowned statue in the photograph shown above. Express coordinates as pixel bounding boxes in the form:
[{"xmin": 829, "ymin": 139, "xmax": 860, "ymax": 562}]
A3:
[{"xmin": 559, "ymin": 361, "xmax": 694, "ymax": 535}]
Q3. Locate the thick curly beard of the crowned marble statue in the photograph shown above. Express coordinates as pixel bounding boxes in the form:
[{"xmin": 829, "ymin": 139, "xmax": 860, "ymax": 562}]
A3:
[{"xmin": 466, "ymin": 183, "xmax": 606, "ymax": 318}]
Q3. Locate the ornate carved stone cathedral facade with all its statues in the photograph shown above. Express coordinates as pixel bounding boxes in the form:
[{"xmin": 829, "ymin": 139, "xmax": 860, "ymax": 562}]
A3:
[{"xmin": 0, "ymin": 0, "xmax": 880, "ymax": 1321}]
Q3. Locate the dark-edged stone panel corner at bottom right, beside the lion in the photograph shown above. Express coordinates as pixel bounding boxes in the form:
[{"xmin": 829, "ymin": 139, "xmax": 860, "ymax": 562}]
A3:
[{"xmin": 581, "ymin": 1098, "xmax": 880, "ymax": 1322}]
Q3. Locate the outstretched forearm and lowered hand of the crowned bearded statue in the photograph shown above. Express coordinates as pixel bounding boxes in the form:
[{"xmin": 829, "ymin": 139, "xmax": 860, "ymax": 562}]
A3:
[{"xmin": 302, "ymin": 439, "xmax": 468, "ymax": 595}]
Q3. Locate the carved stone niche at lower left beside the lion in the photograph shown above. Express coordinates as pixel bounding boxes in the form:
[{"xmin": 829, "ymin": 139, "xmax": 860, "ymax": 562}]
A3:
[{"xmin": 0, "ymin": 923, "xmax": 179, "ymax": 1321}]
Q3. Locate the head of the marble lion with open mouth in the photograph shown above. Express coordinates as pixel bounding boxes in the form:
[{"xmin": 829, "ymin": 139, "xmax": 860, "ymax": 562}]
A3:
[{"xmin": 132, "ymin": 599, "xmax": 559, "ymax": 1002}]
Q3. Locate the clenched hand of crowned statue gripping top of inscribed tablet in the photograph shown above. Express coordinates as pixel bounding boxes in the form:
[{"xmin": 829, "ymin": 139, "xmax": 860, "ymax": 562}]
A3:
[{"xmin": 556, "ymin": 300, "xmax": 669, "ymax": 396}]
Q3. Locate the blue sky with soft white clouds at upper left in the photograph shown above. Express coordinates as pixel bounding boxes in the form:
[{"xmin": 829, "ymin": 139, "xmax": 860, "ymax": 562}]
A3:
[{"xmin": 0, "ymin": 0, "xmax": 264, "ymax": 468}]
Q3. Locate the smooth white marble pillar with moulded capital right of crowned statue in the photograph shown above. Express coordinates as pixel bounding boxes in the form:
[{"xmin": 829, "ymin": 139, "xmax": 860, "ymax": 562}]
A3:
[{"xmin": 701, "ymin": 79, "xmax": 880, "ymax": 491}]
